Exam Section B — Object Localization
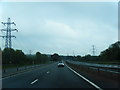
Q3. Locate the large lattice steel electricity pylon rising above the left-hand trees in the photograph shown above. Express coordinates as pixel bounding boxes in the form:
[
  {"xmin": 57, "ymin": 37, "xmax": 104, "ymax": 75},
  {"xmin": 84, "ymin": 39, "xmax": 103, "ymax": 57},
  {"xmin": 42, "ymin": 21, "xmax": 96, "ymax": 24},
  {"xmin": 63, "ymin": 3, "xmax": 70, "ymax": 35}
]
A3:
[{"xmin": 0, "ymin": 18, "xmax": 18, "ymax": 48}]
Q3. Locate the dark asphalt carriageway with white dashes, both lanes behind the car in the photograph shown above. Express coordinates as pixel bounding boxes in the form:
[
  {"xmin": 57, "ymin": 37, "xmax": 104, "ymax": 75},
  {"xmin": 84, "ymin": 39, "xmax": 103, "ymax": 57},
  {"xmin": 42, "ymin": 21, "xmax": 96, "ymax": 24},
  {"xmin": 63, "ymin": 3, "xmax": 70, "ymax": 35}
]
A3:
[{"xmin": 2, "ymin": 62, "xmax": 101, "ymax": 88}]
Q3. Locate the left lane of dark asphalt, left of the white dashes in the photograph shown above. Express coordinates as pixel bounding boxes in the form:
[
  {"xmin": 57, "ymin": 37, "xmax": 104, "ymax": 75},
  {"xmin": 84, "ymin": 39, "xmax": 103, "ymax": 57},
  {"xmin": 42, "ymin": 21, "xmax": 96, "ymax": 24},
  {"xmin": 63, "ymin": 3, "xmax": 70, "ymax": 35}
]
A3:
[{"xmin": 2, "ymin": 63, "xmax": 56, "ymax": 88}]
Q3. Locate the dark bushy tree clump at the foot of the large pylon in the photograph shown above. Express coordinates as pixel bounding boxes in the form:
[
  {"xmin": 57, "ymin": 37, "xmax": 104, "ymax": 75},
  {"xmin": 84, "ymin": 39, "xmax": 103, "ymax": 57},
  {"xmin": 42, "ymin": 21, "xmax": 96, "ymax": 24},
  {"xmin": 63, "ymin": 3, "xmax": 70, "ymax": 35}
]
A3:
[{"xmin": 2, "ymin": 48, "xmax": 26, "ymax": 64}]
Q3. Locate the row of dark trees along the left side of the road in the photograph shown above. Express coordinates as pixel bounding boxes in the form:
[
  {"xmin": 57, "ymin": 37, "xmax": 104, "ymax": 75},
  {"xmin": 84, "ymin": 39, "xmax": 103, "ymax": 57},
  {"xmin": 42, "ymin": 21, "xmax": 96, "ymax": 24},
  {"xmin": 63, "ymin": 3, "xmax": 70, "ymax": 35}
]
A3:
[{"xmin": 2, "ymin": 48, "xmax": 50, "ymax": 65}]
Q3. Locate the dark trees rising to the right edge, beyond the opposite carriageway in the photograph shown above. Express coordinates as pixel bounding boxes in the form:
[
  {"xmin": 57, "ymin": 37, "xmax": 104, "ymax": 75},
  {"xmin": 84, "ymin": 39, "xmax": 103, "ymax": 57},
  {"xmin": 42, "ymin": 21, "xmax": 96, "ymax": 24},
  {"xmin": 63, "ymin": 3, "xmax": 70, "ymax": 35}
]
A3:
[{"xmin": 74, "ymin": 41, "xmax": 120, "ymax": 61}]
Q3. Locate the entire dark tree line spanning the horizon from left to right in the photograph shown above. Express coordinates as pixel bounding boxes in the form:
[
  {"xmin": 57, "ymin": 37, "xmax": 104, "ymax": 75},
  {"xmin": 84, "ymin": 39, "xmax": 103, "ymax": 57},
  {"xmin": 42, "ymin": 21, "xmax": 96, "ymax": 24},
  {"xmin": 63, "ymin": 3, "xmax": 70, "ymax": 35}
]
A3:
[{"xmin": 2, "ymin": 41, "xmax": 120, "ymax": 64}]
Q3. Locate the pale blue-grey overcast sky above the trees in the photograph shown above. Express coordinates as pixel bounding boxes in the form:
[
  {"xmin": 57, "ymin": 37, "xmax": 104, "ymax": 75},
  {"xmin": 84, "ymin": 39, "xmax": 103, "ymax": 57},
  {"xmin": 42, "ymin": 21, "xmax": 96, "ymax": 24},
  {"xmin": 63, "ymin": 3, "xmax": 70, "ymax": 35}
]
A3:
[{"xmin": 0, "ymin": 2, "xmax": 118, "ymax": 56}]
